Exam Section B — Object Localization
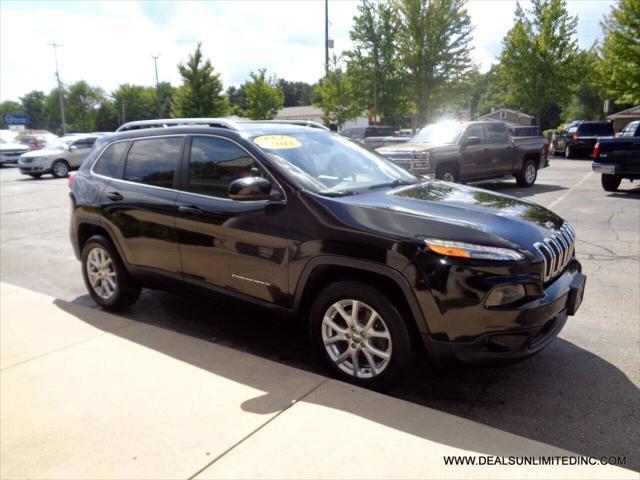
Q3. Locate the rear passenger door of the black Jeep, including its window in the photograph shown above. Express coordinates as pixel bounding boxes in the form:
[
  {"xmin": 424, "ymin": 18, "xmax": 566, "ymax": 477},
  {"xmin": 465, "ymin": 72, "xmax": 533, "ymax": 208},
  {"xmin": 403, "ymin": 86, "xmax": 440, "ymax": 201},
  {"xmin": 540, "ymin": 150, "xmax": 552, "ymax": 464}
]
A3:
[{"xmin": 100, "ymin": 135, "xmax": 186, "ymax": 278}]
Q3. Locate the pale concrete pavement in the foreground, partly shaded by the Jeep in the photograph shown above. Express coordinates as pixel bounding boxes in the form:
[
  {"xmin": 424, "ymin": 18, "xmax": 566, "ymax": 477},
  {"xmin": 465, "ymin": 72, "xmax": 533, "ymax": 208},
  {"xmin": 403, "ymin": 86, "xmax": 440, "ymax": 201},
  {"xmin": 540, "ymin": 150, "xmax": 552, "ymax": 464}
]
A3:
[{"xmin": 0, "ymin": 284, "xmax": 638, "ymax": 478}]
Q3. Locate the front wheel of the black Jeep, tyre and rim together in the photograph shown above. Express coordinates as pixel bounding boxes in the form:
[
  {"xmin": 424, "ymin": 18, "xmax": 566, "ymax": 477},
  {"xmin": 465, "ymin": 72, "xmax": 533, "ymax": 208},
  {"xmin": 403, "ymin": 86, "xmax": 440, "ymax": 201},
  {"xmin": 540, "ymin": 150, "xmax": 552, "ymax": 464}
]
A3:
[{"xmin": 309, "ymin": 281, "xmax": 413, "ymax": 389}]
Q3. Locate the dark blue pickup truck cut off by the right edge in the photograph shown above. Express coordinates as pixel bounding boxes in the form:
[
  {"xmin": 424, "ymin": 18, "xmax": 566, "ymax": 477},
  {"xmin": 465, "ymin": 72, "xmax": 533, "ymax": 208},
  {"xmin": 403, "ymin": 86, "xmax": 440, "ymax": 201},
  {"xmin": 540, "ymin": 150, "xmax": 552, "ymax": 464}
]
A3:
[{"xmin": 592, "ymin": 120, "xmax": 640, "ymax": 192}]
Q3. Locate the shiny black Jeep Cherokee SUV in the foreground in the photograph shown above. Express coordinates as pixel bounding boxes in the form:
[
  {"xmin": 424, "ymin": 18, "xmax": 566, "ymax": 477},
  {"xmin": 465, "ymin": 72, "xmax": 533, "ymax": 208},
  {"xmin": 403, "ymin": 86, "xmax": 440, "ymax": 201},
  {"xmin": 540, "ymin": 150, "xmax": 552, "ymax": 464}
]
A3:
[{"xmin": 70, "ymin": 119, "xmax": 585, "ymax": 387}]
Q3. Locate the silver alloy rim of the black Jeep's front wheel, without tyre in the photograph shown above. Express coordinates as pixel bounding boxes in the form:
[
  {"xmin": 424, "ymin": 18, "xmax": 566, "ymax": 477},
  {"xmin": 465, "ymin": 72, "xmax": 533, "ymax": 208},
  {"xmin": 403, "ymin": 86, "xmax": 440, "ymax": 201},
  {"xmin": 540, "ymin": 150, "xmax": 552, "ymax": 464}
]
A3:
[{"xmin": 322, "ymin": 299, "xmax": 392, "ymax": 378}]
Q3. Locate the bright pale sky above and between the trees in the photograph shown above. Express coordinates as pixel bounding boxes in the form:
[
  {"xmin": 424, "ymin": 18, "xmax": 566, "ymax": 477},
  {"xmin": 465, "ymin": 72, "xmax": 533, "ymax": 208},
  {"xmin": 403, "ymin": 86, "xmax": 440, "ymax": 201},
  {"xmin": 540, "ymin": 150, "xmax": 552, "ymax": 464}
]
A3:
[{"xmin": 0, "ymin": 0, "xmax": 612, "ymax": 100}]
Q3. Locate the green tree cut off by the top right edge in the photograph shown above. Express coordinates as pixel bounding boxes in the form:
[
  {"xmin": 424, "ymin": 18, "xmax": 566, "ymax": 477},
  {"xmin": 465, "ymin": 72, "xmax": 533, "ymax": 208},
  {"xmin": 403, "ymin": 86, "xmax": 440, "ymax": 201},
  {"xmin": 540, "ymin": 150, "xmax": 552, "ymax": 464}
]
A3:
[{"xmin": 600, "ymin": 0, "xmax": 640, "ymax": 104}]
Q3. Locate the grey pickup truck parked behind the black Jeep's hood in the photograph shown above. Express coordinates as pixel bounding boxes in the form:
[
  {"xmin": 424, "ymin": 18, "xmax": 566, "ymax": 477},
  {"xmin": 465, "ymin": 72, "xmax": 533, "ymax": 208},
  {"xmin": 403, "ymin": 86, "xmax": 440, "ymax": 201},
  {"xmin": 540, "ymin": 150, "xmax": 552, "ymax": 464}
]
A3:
[{"xmin": 377, "ymin": 121, "xmax": 549, "ymax": 187}]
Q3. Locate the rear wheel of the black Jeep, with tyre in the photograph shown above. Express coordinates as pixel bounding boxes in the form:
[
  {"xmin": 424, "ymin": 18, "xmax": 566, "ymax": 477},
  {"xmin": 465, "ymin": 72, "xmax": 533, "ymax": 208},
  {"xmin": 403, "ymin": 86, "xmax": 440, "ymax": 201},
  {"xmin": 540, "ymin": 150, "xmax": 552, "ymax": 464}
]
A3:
[{"xmin": 82, "ymin": 235, "xmax": 140, "ymax": 310}]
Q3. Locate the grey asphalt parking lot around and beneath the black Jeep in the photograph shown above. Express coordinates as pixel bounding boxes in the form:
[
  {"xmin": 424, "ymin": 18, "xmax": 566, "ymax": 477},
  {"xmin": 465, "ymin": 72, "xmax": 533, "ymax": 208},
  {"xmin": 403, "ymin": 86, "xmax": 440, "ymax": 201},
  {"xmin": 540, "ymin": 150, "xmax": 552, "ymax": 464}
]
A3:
[{"xmin": 0, "ymin": 157, "xmax": 640, "ymax": 470}]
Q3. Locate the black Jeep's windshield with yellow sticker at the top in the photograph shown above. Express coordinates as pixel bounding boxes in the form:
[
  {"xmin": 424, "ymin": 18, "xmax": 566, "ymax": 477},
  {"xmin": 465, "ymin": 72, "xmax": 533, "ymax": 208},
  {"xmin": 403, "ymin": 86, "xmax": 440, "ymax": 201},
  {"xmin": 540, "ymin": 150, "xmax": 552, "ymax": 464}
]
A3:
[{"xmin": 252, "ymin": 131, "xmax": 419, "ymax": 195}]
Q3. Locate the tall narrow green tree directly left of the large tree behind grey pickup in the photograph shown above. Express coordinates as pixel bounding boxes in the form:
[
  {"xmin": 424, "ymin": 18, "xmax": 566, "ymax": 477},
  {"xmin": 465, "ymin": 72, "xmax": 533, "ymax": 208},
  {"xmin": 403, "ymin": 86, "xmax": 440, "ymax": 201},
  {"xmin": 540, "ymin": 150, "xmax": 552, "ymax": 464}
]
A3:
[{"xmin": 345, "ymin": 0, "xmax": 407, "ymax": 124}]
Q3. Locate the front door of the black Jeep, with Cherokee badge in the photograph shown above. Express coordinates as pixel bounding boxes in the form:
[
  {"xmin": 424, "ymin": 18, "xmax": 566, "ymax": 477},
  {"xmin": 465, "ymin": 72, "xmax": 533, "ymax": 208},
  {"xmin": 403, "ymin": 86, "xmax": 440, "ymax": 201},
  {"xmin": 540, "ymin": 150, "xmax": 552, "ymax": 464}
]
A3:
[{"xmin": 176, "ymin": 135, "xmax": 288, "ymax": 304}]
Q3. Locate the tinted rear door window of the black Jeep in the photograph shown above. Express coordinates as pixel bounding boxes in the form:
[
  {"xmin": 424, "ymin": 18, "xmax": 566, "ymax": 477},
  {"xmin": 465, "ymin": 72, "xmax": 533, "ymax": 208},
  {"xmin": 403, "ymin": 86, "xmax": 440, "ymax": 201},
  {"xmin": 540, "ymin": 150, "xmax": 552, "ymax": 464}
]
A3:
[{"xmin": 123, "ymin": 137, "xmax": 183, "ymax": 188}]
